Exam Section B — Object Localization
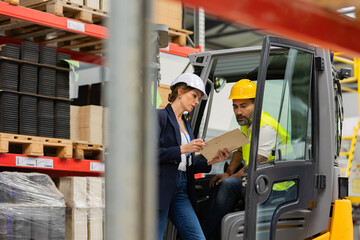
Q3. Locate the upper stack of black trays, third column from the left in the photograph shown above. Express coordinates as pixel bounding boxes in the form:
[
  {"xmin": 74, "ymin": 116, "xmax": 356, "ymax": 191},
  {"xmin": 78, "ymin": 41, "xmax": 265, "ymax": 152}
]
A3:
[{"xmin": 38, "ymin": 46, "xmax": 56, "ymax": 97}]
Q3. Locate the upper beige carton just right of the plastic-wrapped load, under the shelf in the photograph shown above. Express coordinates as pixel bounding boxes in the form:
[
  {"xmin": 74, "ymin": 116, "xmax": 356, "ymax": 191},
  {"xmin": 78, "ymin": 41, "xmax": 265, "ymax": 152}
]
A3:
[{"xmin": 58, "ymin": 177, "xmax": 87, "ymax": 208}]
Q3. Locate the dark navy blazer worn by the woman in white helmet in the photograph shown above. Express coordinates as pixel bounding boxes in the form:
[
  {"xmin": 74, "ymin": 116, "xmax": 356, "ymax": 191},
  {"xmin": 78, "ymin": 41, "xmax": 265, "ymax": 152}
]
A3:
[{"xmin": 157, "ymin": 104, "xmax": 211, "ymax": 211}]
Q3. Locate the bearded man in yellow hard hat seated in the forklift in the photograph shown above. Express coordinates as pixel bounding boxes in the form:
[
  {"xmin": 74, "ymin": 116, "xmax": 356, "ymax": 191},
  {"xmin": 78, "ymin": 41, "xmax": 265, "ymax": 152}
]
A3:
[{"xmin": 204, "ymin": 79, "xmax": 294, "ymax": 240}]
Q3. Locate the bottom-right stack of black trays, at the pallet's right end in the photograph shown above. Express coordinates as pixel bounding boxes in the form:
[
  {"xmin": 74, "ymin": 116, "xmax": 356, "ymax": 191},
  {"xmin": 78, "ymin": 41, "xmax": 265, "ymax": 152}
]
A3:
[{"xmin": 55, "ymin": 100, "xmax": 70, "ymax": 139}]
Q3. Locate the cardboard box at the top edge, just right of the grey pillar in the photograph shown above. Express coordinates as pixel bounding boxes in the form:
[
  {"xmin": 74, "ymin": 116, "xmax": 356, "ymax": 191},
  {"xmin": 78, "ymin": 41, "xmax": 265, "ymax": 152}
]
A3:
[{"xmin": 153, "ymin": 0, "xmax": 183, "ymax": 29}]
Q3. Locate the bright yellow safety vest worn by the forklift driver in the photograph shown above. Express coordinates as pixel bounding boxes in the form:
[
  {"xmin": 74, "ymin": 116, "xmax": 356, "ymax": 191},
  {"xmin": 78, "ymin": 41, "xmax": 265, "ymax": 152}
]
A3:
[{"xmin": 241, "ymin": 111, "xmax": 295, "ymax": 191}]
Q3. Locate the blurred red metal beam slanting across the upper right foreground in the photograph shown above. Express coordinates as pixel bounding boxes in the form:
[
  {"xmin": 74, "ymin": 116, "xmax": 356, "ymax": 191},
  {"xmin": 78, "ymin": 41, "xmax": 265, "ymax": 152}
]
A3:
[{"xmin": 181, "ymin": 0, "xmax": 360, "ymax": 56}]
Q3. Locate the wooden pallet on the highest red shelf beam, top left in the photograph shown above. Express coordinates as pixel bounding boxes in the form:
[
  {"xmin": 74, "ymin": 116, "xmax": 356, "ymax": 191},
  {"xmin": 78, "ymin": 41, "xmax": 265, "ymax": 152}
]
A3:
[{"xmin": 20, "ymin": 0, "xmax": 108, "ymax": 24}]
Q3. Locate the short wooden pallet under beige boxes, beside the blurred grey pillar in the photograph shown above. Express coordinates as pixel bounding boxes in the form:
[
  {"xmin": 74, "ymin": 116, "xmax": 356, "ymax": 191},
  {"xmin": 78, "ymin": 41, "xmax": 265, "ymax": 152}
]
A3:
[{"xmin": 73, "ymin": 141, "xmax": 105, "ymax": 161}]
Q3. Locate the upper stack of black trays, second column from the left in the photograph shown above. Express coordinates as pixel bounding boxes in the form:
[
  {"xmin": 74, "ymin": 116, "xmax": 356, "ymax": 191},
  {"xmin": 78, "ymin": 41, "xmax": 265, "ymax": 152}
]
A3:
[{"xmin": 19, "ymin": 42, "xmax": 39, "ymax": 94}]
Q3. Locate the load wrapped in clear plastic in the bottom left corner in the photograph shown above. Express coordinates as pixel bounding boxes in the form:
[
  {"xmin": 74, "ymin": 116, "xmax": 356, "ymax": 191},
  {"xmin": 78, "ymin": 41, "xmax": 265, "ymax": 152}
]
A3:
[{"xmin": 0, "ymin": 172, "xmax": 65, "ymax": 240}]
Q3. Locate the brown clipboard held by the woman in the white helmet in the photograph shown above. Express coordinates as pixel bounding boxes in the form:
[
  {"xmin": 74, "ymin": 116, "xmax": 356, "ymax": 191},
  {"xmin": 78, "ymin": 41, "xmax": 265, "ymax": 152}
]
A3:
[{"xmin": 199, "ymin": 128, "xmax": 249, "ymax": 162}]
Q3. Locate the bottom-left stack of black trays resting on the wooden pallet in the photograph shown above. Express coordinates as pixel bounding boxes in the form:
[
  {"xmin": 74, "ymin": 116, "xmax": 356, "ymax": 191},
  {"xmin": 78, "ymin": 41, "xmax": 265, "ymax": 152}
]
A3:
[{"xmin": 0, "ymin": 92, "xmax": 19, "ymax": 134}]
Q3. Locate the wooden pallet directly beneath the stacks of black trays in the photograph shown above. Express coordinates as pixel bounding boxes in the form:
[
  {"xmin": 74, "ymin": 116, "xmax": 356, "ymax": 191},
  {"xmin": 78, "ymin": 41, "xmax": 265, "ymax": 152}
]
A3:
[{"xmin": 0, "ymin": 133, "xmax": 72, "ymax": 158}]
